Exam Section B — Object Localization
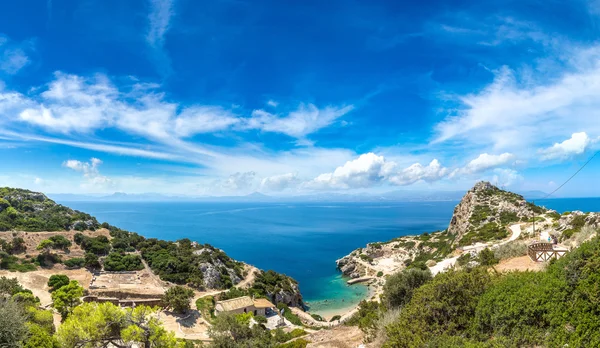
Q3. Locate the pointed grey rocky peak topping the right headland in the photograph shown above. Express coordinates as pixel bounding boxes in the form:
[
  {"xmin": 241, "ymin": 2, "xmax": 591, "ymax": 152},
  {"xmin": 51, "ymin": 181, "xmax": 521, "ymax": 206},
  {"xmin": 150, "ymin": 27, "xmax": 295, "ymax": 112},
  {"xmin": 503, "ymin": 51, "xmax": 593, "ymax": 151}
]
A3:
[{"xmin": 448, "ymin": 181, "xmax": 546, "ymax": 245}]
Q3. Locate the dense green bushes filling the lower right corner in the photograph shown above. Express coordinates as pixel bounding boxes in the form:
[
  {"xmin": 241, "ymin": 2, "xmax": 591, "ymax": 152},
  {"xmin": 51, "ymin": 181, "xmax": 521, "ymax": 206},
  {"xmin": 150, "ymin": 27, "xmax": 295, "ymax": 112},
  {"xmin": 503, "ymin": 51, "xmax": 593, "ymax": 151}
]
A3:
[{"xmin": 349, "ymin": 228, "xmax": 600, "ymax": 347}]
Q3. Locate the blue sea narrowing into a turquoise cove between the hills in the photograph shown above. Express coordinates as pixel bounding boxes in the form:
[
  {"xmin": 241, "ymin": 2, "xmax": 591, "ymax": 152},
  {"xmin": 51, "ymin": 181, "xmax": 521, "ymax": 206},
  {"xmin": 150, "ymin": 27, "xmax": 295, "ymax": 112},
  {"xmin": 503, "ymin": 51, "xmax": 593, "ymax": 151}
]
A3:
[{"xmin": 62, "ymin": 198, "xmax": 600, "ymax": 315}]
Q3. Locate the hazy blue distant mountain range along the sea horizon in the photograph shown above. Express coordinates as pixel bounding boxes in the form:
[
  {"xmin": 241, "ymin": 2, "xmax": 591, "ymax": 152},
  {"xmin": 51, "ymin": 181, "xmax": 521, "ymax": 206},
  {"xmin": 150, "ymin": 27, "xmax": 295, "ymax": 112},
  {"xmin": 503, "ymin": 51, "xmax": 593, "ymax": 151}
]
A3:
[{"xmin": 48, "ymin": 190, "xmax": 546, "ymax": 202}]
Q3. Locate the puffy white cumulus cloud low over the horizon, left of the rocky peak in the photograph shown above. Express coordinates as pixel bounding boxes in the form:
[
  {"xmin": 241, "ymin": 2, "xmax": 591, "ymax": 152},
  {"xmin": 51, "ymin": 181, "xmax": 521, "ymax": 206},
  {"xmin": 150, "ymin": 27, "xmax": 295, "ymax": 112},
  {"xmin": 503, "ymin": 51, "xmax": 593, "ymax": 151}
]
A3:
[{"xmin": 302, "ymin": 153, "xmax": 448, "ymax": 190}]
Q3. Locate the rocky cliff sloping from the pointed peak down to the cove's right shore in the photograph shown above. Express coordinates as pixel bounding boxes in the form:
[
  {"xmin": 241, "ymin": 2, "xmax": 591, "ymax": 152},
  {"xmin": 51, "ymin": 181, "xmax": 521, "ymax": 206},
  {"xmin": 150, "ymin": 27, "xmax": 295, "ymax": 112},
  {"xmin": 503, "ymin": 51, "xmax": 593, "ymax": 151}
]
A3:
[{"xmin": 336, "ymin": 182, "xmax": 556, "ymax": 278}]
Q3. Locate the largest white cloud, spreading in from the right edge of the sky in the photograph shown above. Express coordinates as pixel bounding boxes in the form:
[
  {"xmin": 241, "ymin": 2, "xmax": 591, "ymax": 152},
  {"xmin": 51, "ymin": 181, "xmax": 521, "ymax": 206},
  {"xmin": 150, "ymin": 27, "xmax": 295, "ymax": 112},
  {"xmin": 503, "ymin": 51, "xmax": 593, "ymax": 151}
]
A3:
[{"xmin": 433, "ymin": 46, "xmax": 600, "ymax": 156}]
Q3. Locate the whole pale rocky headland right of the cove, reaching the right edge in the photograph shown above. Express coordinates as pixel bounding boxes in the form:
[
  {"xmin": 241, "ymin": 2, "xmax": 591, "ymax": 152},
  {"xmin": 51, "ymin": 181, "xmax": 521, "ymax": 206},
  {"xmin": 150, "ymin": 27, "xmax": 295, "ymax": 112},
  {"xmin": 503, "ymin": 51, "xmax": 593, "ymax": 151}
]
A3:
[{"xmin": 336, "ymin": 182, "xmax": 600, "ymax": 286}]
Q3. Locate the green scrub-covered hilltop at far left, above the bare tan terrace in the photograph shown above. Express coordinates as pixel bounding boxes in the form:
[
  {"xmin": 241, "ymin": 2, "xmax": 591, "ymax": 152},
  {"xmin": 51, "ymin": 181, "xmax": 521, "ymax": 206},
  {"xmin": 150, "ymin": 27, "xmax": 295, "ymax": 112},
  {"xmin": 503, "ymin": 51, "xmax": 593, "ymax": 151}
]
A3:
[{"xmin": 0, "ymin": 187, "xmax": 99, "ymax": 232}]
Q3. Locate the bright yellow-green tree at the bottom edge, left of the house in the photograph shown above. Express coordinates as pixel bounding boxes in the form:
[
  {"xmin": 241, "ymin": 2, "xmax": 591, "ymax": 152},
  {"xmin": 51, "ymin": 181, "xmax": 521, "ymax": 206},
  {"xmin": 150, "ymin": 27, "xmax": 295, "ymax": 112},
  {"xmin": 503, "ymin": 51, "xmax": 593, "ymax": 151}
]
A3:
[{"xmin": 57, "ymin": 302, "xmax": 184, "ymax": 348}]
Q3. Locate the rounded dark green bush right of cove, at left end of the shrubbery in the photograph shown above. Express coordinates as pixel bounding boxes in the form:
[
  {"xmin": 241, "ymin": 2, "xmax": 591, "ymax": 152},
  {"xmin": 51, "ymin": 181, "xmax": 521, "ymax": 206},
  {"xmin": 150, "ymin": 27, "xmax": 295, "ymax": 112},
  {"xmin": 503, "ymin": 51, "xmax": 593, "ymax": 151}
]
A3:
[{"xmin": 383, "ymin": 268, "xmax": 432, "ymax": 308}]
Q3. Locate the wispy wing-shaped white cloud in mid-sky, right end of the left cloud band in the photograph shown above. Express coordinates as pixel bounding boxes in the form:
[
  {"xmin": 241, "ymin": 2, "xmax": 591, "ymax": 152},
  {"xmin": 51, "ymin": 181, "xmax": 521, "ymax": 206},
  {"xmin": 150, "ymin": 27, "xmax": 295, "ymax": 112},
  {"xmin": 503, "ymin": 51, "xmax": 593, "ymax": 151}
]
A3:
[{"xmin": 246, "ymin": 104, "xmax": 354, "ymax": 138}]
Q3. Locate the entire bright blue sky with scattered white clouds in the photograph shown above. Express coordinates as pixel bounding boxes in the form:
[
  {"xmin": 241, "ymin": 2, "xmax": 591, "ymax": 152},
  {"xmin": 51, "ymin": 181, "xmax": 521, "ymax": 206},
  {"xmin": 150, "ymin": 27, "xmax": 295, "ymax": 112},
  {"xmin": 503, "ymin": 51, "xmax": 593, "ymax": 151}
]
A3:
[{"xmin": 0, "ymin": 0, "xmax": 600, "ymax": 196}]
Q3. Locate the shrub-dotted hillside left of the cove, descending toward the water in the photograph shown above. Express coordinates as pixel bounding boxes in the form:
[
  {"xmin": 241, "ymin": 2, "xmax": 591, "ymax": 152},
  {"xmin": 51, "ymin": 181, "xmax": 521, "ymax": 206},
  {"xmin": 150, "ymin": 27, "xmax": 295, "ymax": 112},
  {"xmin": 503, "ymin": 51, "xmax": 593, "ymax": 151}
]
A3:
[{"xmin": 0, "ymin": 188, "xmax": 302, "ymax": 306}]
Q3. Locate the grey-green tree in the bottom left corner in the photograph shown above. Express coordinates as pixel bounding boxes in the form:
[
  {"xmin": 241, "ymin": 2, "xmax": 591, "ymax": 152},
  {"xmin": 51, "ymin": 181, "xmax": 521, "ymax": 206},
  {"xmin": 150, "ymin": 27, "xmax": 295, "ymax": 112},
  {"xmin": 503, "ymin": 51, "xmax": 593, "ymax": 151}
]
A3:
[{"xmin": 0, "ymin": 296, "xmax": 28, "ymax": 348}]
